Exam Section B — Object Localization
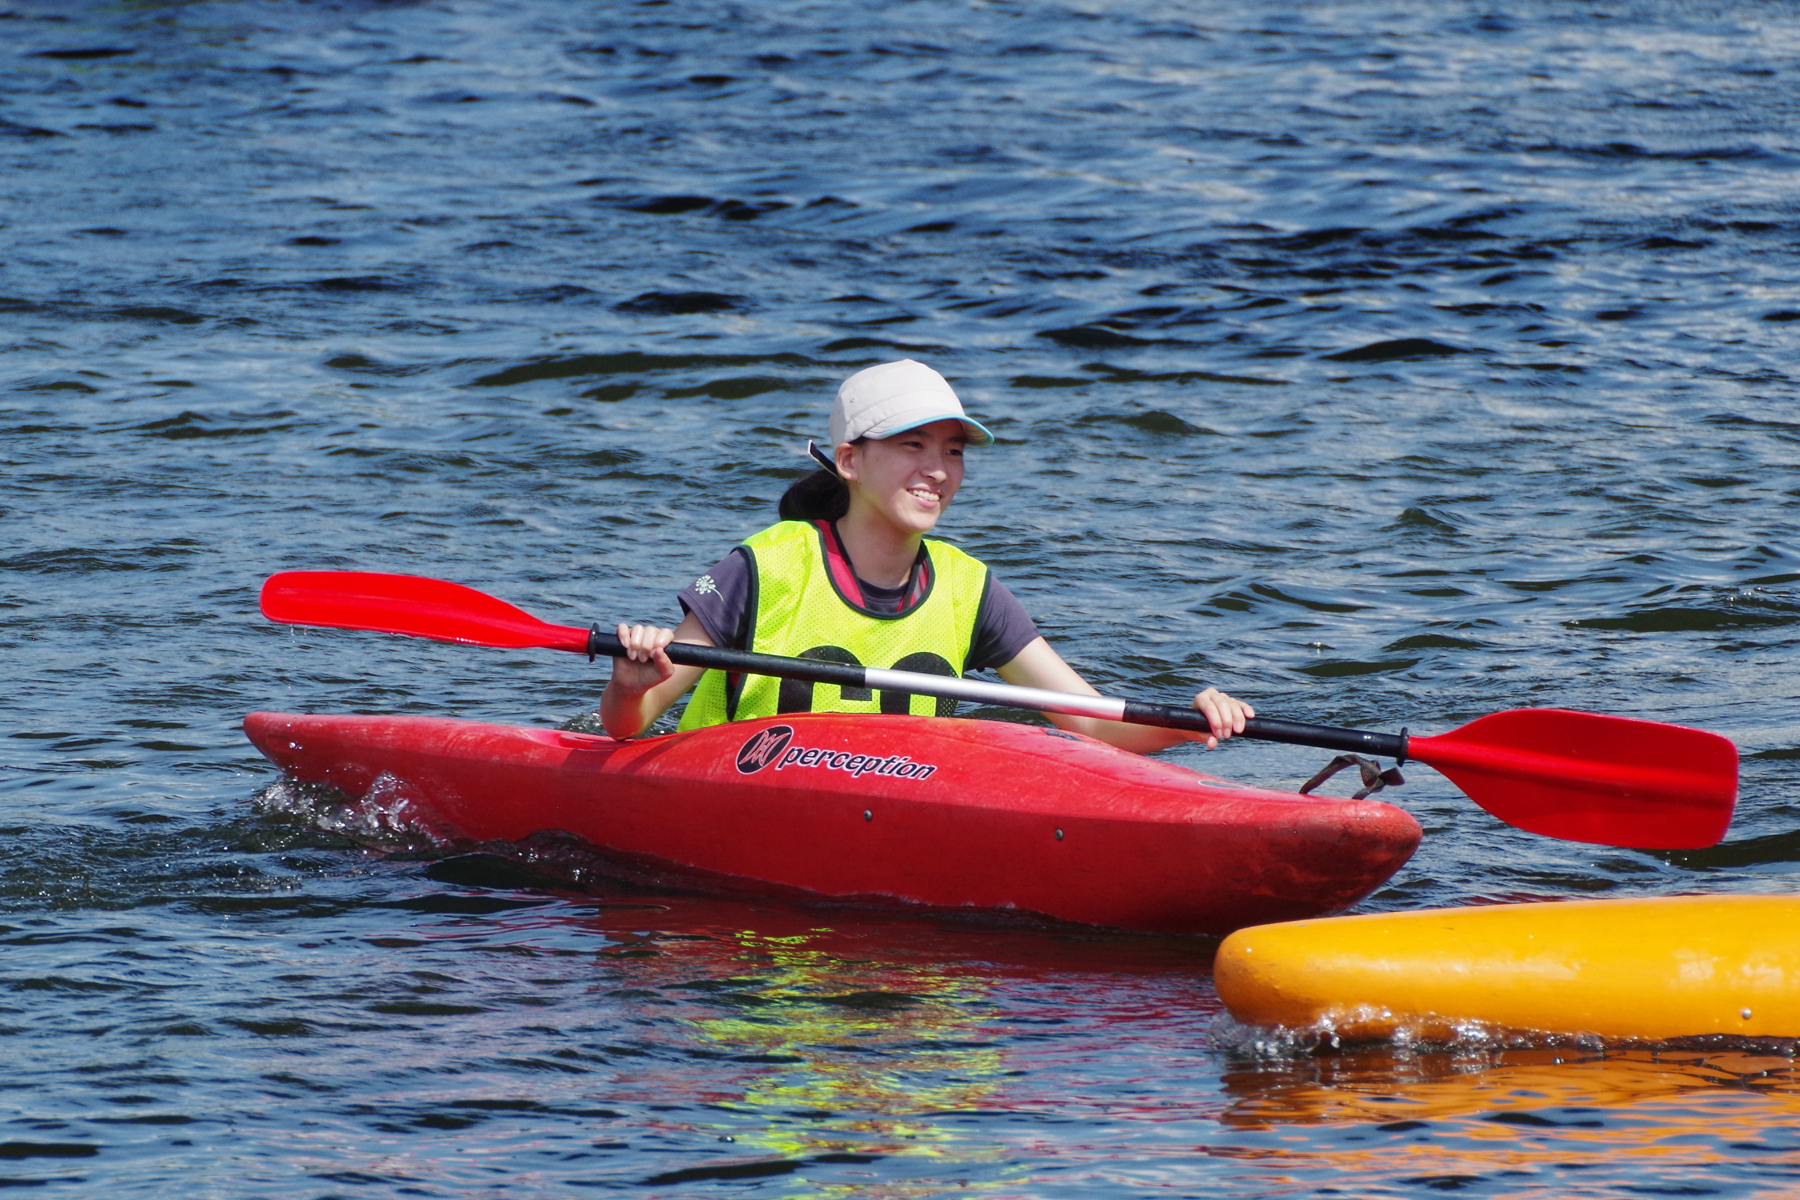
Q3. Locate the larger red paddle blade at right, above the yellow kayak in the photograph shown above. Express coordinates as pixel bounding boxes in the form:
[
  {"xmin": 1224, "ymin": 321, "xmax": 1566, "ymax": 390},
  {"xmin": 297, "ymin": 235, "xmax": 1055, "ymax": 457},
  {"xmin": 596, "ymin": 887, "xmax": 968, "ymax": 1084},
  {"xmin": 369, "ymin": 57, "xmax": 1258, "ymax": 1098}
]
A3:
[{"xmin": 1408, "ymin": 709, "xmax": 1737, "ymax": 849}]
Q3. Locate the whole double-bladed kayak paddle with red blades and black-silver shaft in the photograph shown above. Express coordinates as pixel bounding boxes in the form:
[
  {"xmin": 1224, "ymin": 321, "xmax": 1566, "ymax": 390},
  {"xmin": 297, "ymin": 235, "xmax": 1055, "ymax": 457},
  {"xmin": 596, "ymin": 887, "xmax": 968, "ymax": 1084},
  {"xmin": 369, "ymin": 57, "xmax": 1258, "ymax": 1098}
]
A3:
[{"xmin": 263, "ymin": 570, "xmax": 1737, "ymax": 849}]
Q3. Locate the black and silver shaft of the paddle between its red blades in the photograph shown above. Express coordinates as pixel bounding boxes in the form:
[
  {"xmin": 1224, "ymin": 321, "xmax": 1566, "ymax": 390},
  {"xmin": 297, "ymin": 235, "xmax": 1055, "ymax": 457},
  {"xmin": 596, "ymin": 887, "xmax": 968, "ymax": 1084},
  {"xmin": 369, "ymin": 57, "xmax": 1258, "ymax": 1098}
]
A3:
[{"xmin": 587, "ymin": 626, "xmax": 1406, "ymax": 763}]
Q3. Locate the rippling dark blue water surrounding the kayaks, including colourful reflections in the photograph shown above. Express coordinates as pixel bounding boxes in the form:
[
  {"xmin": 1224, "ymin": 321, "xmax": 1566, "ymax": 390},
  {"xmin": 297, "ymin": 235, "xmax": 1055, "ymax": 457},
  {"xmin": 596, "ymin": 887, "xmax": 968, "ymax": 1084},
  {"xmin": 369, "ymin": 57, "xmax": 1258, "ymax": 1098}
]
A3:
[{"xmin": 0, "ymin": 0, "xmax": 1800, "ymax": 1198}]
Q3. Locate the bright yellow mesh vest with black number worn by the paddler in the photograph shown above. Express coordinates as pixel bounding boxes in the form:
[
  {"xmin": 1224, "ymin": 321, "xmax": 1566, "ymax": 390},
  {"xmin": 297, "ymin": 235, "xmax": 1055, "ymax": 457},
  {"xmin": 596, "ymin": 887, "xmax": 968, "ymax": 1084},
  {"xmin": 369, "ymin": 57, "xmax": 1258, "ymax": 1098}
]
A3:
[{"xmin": 680, "ymin": 522, "xmax": 988, "ymax": 729}]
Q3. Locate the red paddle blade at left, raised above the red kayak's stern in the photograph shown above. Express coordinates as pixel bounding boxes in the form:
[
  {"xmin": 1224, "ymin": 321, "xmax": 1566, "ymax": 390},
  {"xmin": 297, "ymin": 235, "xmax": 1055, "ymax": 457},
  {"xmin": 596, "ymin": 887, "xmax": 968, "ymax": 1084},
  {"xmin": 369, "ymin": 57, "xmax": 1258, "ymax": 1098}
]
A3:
[{"xmin": 263, "ymin": 570, "xmax": 587, "ymax": 653}]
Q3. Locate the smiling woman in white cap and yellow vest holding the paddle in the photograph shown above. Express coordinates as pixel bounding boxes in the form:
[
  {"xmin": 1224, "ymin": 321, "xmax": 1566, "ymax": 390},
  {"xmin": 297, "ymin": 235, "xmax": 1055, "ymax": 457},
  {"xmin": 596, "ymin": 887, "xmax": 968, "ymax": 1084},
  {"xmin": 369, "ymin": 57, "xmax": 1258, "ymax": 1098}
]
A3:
[{"xmin": 599, "ymin": 358, "xmax": 1256, "ymax": 754}]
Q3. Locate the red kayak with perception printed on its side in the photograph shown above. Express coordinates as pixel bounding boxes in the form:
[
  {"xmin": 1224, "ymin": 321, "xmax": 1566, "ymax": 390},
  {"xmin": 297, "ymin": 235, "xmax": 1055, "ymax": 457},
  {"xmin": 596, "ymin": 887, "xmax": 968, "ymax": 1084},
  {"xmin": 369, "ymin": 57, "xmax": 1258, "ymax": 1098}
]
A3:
[{"xmin": 245, "ymin": 712, "xmax": 1420, "ymax": 934}]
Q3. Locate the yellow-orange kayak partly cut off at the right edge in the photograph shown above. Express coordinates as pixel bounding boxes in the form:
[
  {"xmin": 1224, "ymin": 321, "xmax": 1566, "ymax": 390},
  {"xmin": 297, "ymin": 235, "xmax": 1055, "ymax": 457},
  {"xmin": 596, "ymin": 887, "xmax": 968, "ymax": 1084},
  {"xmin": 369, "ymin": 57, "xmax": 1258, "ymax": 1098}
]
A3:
[{"xmin": 1213, "ymin": 896, "xmax": 1800, "ymax": 1042}]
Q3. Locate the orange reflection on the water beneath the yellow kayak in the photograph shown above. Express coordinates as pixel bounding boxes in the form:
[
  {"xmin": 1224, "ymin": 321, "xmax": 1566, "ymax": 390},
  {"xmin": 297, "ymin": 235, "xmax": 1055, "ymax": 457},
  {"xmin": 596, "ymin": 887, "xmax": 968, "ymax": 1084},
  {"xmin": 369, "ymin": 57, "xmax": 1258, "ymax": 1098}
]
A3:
[{"xmin": 1215, "ymin": 1051, "xmax": 1800, "ymax": 1195}]
